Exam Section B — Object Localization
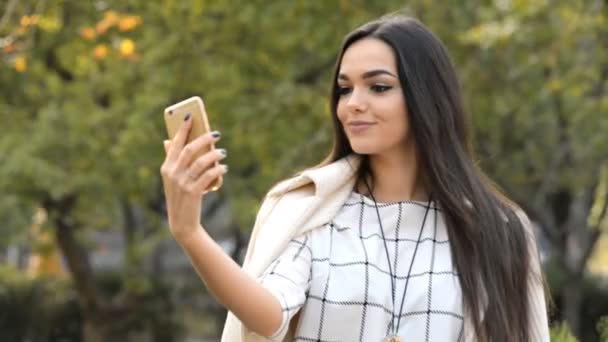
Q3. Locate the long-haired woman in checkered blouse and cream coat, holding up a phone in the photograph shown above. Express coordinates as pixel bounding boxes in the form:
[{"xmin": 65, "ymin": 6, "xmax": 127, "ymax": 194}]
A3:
[{"xmin": 161, "ymin": 17, "xmax": 549, "ymax": 341}]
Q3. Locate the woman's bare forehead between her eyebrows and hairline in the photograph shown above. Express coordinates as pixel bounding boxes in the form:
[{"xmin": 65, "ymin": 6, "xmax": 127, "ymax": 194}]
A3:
[{"xmin": 340, "ymin": 38, "xmax": 397, "ymax": 76}]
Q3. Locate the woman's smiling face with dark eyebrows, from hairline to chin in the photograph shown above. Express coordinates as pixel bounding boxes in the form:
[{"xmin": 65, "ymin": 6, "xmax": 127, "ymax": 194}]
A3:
[{"xmin": 337, "ymin": 38, "xmax": 408, "ymax": 154}]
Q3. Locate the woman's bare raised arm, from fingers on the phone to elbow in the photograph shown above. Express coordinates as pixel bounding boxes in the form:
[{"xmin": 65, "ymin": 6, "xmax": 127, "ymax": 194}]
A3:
[{"xmin": 161, "ymin": 116, "xmax": 282, "ymax": 336}]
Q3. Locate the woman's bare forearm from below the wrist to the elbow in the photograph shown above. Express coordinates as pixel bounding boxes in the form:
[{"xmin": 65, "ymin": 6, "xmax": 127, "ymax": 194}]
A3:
[{"xmin": 178, "ymin": 229, "xmax": 282, "ymax": 336}]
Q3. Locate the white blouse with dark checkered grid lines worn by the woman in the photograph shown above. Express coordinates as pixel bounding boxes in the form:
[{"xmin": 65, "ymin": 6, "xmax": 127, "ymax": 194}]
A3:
[{"xmin": 259, "ymin": 192, "xmax": 463, "ymax": 342}]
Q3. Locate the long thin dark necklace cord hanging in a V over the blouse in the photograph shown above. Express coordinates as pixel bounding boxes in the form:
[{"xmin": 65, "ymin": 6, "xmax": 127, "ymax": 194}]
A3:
[{"xmin": 363, "ymin": 177, "xmax": 432, "ymax": 342}]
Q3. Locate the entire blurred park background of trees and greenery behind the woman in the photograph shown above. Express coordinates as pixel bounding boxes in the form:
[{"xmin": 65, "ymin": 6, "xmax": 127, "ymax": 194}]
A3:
[{"xmin": 0, "ymin": 0, "xmax": 608, "ymax": 342}]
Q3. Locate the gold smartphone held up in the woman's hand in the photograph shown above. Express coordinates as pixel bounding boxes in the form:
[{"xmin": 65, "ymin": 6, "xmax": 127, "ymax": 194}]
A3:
[{"xmin": 165, "ymin": 96, "xmax": 223, "ymax": 191}]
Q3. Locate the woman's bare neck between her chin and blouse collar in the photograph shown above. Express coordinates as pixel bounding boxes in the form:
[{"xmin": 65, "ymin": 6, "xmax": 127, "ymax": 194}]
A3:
[{"xmin": 358, "ymin": 145, "xmax": 429, "ymax": 202}]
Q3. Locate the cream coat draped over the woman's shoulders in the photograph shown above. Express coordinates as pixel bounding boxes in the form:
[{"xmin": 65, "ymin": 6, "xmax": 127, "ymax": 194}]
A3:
[{"xmin": 221, "ymin": 155, "xmax": 549, "ymax": 342}]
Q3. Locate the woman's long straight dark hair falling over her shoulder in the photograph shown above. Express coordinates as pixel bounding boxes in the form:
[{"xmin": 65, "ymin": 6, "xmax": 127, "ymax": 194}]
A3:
[{"xmin": 318, "ymin": 15, "xmax": 548, "ymax": 341}]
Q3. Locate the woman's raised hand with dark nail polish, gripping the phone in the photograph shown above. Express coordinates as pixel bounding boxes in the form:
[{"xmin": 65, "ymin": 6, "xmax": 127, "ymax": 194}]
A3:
[{"xmin": 160, "ymin": 117, "xmax": 228, "ymax": 242}]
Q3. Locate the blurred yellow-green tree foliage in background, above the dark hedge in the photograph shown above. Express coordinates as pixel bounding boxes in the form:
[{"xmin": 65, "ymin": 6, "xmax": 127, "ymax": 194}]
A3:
[{"xmin": 0, "ymin": 0, "xmax": 608, "ymax": 338}]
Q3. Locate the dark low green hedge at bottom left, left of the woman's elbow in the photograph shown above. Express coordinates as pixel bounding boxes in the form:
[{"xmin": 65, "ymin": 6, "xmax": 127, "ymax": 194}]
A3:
[{"xmin": 0, "ymin": 266, "xmax": 183, "ymax": 341}]
